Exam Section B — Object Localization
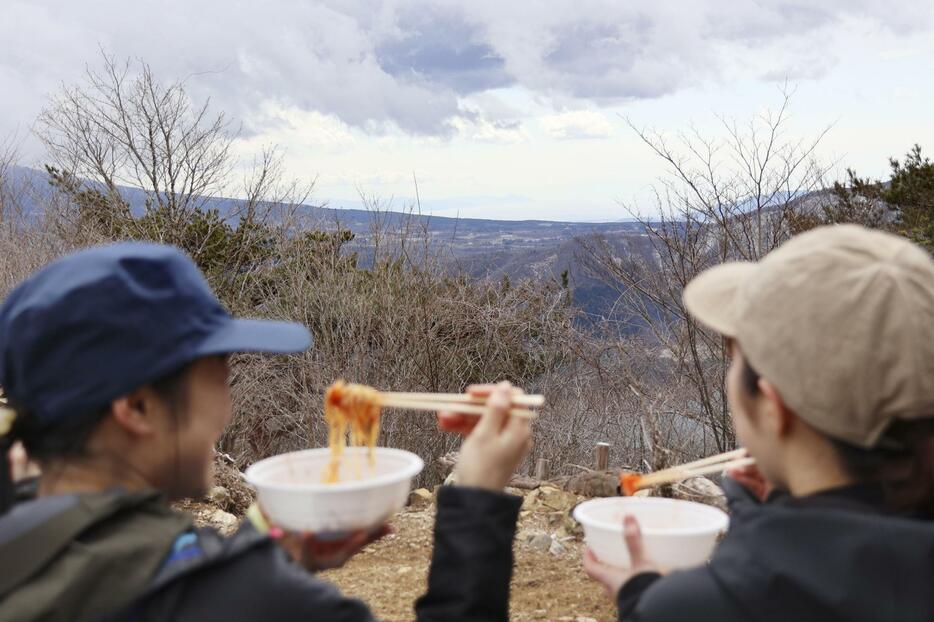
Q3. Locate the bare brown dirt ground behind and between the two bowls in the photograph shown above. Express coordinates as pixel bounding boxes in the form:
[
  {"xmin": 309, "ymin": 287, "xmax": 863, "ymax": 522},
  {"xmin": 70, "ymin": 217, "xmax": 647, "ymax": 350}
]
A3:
[{"xmin": 178, "ymin": 454, "xmax": 640, "ymax": 622}]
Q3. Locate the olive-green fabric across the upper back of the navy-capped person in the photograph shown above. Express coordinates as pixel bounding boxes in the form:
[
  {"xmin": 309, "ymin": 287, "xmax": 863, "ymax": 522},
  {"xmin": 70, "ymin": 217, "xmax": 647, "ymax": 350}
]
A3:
[{"xmin": 0, "ymin": 491, "xmax": 192, "ymax": 622}]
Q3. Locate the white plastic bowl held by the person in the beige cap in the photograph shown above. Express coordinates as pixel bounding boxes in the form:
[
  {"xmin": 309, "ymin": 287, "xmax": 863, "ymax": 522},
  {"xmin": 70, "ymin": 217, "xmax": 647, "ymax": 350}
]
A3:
[{"xmin": 574, "ymin": 497, "xmax": 730, "ymax": 570}]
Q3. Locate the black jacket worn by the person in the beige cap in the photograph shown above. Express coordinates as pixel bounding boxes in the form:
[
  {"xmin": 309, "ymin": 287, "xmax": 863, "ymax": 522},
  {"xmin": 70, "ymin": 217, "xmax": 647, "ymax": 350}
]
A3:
[{"xmin": 619, "ymin": 482, "xmax": 934, "ymax": 622}]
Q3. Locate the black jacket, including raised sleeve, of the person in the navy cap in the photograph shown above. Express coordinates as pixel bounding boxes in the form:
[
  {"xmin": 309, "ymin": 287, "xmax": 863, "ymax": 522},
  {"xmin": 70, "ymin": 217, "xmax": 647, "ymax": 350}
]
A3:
[{"xmin": 0, "ymin": 486, "xmax": 521, "ymax": 622}]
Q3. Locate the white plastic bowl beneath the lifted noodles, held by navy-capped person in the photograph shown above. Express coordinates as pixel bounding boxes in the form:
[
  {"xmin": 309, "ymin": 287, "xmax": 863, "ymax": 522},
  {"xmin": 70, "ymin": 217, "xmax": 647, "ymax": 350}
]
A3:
[{"xmin": 245, "ymin": 447, "xmax": 425, "ymax": 533}]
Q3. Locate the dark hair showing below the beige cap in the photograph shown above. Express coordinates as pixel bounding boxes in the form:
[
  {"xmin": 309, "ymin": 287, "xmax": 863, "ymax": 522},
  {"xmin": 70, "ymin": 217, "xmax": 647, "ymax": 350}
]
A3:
[{"xmin": 742, "ymin": 360, "xmax": 934, "ymax": 517}]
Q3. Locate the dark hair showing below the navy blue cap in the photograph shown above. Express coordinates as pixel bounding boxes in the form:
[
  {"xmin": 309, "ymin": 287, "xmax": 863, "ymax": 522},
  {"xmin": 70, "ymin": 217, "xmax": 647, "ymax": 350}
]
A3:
[{"xmin": 0, "ymin": 365, "xmax": 190, "ymax": 514}]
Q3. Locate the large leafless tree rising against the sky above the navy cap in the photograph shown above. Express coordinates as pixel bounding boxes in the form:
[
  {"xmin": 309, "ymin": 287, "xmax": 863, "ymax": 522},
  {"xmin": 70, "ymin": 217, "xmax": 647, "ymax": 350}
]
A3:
[{"xmin": 36, "ymin": 54, "xmax": 314, "ymax": 294}]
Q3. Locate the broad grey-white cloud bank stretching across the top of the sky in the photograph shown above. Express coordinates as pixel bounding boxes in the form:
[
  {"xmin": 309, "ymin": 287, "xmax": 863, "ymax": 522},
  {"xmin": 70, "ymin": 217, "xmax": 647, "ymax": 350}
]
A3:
[{"xmin": 0, "ymin": 0, "xmax": 931, "ymax": 150}]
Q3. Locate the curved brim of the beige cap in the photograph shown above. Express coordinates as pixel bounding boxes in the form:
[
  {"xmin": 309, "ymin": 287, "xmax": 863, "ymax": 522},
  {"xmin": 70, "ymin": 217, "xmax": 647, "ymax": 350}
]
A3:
[{"xmin": 683, "ymin": 262, "xmax": 758, "ymax": 337}]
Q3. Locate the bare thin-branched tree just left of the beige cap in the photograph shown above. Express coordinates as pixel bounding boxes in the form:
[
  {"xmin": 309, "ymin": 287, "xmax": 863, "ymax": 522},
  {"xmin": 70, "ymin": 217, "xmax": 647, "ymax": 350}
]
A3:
[{"xmin": 581, "ymin": 91, "xmax": 827, "ymax": 451}]
